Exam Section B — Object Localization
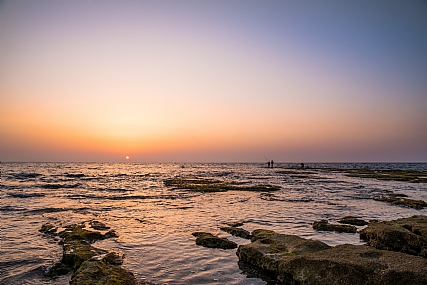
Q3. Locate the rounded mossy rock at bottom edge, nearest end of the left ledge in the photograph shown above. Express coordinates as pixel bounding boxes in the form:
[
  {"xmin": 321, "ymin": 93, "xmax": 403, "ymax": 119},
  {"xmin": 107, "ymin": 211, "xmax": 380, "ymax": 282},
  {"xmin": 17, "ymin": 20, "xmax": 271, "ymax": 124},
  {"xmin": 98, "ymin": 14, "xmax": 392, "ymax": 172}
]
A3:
[{"xmin": 70, "ymin": 260, "xmax": 142, "ymax": 285}]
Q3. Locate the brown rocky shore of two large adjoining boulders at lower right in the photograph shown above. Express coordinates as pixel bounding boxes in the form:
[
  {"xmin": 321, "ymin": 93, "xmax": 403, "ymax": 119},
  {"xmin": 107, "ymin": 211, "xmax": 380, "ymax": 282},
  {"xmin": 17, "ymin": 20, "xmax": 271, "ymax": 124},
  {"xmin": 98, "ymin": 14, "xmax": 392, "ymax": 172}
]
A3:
[{"xmin": 237, "ymin": 216, "xmax": 427, "ymax": 285}]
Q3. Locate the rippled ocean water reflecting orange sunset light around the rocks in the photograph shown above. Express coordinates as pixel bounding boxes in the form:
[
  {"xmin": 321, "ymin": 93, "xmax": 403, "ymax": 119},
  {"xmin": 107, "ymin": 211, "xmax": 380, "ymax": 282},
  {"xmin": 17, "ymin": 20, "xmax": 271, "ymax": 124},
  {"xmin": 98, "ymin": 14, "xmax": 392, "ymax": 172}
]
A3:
[{"xmin": 0, "ymin": 163, "xmax": 427, "ymax": 284}]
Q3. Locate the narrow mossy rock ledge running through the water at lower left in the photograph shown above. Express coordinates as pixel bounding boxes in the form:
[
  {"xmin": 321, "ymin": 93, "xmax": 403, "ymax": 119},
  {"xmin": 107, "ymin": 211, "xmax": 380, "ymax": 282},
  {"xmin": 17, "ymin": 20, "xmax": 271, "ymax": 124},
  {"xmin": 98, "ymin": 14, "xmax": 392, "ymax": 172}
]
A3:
[{"xmin": 39, "ymin": 222, "xmax": 145, "ymax": 285}]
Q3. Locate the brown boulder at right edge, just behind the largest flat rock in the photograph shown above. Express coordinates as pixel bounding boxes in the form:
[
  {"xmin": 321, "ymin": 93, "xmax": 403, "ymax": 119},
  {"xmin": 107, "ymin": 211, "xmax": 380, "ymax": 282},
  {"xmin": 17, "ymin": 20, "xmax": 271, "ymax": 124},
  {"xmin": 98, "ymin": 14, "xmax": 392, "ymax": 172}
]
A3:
[{"xmin": 359, "ymin": 216, "xmax": 427, "ymax": 258}]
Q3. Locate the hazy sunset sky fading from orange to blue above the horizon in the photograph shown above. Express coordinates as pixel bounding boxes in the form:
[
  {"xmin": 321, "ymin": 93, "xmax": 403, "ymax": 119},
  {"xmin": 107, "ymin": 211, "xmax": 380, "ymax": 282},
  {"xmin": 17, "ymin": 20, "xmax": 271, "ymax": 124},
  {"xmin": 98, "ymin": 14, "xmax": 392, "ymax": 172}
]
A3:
[{"xmin": 0, "ymin": 0, "xmax": 427, "ymax": 162}]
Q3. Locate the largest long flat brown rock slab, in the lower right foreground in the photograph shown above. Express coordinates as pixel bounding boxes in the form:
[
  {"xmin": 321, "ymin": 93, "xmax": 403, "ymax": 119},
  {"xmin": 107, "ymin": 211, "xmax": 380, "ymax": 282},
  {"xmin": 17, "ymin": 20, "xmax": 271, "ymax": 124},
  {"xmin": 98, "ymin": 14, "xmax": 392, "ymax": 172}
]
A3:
[{"xmin": 237, "ymin": 230, "xmax": 427, "ymax": 285}]
